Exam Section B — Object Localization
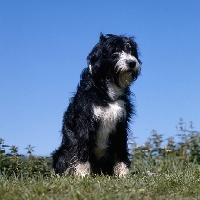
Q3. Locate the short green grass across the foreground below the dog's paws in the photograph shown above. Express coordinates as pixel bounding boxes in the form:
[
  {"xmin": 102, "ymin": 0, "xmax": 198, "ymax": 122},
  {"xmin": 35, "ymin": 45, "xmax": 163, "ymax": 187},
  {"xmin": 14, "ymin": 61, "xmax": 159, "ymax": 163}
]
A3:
[{"xmin": 0, "ymin": 163, "xmax": 200, "ymax": 200}]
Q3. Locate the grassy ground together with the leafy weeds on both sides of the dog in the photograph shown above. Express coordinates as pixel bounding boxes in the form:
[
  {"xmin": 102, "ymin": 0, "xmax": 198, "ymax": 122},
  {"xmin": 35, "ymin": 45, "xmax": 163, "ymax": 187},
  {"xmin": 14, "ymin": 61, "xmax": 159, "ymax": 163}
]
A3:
[{"xmin": 0, "ymin": 119, "xmax": 200, "ymax": 200}]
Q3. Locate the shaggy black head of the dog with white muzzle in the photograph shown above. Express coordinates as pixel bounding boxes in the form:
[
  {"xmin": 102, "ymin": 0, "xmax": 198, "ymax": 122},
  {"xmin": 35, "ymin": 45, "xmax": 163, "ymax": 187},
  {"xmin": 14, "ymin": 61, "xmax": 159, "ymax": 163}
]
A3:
[{"xmin": 87, "ymin": 34, "xmax": 142, "ymax": 88}]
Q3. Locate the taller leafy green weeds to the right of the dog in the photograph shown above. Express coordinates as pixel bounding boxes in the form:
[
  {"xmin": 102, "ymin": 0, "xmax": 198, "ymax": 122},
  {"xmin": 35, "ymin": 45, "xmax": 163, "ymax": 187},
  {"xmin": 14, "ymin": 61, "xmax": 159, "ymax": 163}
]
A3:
[{"xmin": 131, "ymin": 119, "xmax": 200, "ymax": 172}]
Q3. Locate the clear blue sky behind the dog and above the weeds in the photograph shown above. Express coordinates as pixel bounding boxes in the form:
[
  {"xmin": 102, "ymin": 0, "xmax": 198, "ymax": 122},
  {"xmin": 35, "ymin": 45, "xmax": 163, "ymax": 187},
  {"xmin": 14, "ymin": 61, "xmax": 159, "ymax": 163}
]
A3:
[{"xmin": 0, "ymin": 0, "xmax": 200, "ymax": 155}]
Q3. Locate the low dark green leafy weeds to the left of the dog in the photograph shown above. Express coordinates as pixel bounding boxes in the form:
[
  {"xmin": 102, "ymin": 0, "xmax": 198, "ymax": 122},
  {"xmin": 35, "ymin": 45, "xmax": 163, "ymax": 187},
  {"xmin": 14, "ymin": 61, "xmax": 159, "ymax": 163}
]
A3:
[{"xmin": 0, "ymin": 138, "xmax": 51, "ymax": 176}]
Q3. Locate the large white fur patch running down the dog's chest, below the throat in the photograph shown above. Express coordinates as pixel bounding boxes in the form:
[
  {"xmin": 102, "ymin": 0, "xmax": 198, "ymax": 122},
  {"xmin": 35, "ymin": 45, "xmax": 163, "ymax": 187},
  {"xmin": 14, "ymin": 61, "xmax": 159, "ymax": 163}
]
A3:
[{"xmin": 94, "ymin": 100, "xmax": 126, "ymax": 158}]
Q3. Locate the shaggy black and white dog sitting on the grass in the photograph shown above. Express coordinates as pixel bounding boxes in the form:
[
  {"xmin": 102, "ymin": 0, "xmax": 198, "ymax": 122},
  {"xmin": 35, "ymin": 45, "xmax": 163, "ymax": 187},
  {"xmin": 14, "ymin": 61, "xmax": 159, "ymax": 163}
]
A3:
[{"xmin": 52, "ymin": 34, "xmax": 141, "ymax": 177}]
